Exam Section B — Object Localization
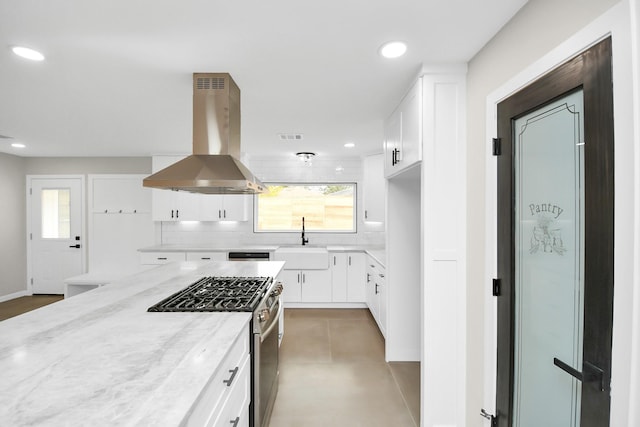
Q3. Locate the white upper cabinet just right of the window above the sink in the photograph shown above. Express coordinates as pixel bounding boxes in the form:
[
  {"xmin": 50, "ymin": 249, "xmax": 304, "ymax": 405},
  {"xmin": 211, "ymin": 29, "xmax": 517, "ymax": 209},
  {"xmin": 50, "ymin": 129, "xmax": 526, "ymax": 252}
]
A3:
[{"xmin": 362, "ymin": 154, "xmax": 386, "ymax": 222}]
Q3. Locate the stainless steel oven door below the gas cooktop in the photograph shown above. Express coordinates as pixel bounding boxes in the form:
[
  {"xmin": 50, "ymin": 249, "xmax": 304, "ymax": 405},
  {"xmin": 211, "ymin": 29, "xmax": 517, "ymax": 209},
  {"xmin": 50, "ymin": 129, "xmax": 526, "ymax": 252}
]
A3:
[{"xmin": 253, "ymin": 298, "xmax": 282, "ymax": 427}]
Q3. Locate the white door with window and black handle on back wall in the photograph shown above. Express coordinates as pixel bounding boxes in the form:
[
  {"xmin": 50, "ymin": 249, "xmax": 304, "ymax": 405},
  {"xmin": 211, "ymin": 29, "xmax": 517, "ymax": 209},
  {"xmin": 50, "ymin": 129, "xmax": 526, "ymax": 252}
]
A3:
[{"xmin": 29, "ymin": 177, "xmax": 84, "ymax": 294}]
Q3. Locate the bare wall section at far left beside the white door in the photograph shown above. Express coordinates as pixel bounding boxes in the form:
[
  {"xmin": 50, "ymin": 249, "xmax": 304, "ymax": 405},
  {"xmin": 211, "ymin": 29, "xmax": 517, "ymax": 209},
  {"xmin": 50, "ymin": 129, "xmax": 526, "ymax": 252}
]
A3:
[{"xmin": 0, "ymin": 153, "xmax": 27, "ymax": 301}]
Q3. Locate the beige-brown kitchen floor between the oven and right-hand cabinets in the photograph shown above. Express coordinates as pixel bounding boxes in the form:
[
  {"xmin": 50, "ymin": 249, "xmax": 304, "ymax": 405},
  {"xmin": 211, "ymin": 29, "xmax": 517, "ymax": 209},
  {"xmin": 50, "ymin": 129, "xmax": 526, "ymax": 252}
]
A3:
[{"xmin": 270, "ymin": 309, "xmax": 420, "ymax": 427}]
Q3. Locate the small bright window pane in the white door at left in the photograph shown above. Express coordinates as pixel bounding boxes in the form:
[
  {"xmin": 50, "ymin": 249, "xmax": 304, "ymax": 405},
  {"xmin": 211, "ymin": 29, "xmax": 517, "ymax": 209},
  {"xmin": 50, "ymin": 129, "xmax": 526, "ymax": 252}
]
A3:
[{"xmin": 42, "ymin": 188, "xmax": 71, "ymax": 239}]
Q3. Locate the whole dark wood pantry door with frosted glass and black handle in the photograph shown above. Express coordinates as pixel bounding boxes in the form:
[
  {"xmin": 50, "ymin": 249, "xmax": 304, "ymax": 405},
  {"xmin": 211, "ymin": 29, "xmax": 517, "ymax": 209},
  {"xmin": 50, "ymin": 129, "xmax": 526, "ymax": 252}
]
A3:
[{"xmin": 496, "ymin": 39, "xmax": 614, "ymax": 427}]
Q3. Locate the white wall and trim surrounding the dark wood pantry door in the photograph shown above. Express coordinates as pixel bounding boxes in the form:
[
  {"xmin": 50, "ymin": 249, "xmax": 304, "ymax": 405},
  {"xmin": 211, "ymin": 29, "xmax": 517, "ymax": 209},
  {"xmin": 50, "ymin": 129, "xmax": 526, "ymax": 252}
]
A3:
[{"xmin": 467, "ymin": 0, "xmax": 639, "ymax": 426}]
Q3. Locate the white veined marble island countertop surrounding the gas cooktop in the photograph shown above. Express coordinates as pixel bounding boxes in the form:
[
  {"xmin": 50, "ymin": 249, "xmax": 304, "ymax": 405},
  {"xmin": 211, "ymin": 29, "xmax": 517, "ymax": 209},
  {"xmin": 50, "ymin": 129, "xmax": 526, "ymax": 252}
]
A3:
[{"xmin": 0, "ymin": 262, "xmax": 284, "ymax": 426}]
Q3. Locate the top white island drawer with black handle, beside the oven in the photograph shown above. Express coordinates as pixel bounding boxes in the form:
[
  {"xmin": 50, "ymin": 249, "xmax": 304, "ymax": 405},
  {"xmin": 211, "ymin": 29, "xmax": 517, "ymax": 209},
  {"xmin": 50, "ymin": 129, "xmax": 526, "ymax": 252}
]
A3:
[{"xmin": 184, "ymin": 327, "xmax": 251, "ymax": 426}]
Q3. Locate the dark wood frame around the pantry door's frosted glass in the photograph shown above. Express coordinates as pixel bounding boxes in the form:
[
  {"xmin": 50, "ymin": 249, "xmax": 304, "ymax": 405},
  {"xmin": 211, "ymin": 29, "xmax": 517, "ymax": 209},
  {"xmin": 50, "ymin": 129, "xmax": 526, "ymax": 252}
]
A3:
[{"xmin": 496, "ymin": 38, "xmax": 614, "ymax": 427}]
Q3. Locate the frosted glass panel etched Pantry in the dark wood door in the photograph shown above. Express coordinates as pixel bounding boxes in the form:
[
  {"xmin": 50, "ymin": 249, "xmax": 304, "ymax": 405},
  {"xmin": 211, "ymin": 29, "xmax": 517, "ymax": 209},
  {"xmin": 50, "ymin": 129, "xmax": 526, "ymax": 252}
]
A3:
[{"xmin": 513, "ymin": 91, "xmax": 584, "ymax": 427}]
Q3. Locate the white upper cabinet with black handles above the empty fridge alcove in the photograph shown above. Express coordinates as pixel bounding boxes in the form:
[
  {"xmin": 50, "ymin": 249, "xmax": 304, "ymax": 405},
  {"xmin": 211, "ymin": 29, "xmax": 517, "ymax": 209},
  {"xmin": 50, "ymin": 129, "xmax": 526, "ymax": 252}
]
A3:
[{"xmin": 384, "ymin": 78, "xmax": 422, "ymax": 177}]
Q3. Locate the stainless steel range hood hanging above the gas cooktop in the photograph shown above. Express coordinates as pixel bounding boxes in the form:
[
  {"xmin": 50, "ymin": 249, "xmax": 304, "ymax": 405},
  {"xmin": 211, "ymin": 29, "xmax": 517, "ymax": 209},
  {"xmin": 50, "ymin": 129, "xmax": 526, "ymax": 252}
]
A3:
[{"xmin": 142, "ymin": 73, "xmax": 266, "ymax": 194}]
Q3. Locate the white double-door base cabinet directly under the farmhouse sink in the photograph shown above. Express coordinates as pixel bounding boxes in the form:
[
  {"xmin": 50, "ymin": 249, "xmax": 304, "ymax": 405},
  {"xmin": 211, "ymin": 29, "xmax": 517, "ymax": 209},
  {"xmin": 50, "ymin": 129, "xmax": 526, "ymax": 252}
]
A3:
[{"xmin": 281, "ymin": 269, "xmax": 331, "ymax": 303}]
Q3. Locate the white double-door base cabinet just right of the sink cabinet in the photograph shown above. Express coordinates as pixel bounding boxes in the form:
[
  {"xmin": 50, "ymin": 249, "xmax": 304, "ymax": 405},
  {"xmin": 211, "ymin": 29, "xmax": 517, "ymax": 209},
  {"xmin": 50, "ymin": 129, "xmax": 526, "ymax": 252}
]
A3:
[{"xmin": 329, "ymin": 252, "xmax": 366, "ymax": 302}]
